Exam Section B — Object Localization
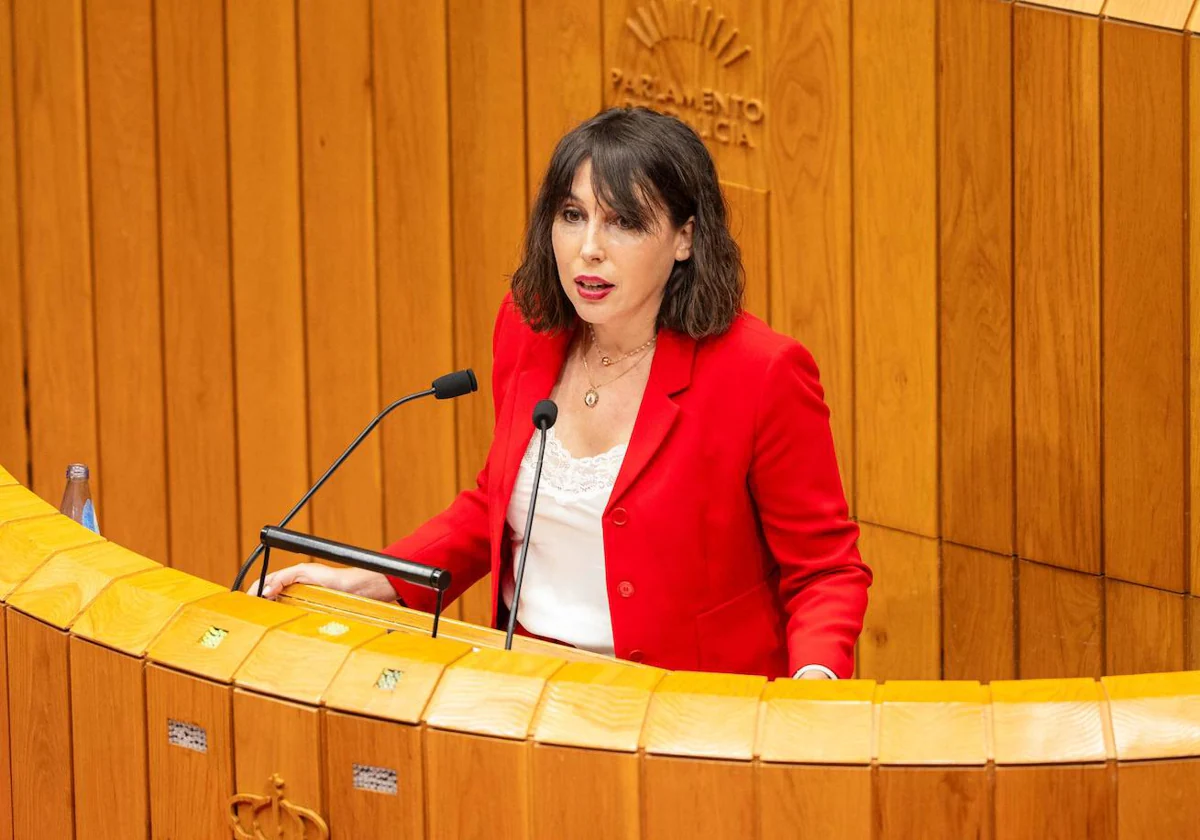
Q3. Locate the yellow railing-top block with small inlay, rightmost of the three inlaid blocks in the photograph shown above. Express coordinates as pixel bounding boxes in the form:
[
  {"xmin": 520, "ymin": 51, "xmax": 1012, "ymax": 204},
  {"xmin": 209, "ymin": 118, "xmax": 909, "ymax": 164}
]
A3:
[{"xmin": 325, "ymin": 632, "xmax": 470, "ymax": 724}]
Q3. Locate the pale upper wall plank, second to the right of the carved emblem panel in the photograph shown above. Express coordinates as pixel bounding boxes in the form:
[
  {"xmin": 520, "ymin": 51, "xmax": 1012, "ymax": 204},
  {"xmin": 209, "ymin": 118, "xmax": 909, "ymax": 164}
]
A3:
[{"xmin": 853, "ymin": 0, "xmax": 938, "ymax": 536}]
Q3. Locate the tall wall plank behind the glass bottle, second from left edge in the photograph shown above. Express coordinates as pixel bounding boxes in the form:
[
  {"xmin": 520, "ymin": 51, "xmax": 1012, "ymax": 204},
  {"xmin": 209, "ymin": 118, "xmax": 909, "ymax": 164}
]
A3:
[{"xmin": 12, "ymin": 0, "xmax": 104, "ymax": 506}]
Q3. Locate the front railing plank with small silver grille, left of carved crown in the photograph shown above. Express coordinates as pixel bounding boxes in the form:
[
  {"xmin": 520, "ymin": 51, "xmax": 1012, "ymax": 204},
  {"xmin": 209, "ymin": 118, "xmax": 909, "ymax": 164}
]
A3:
[{"xmin": 146, "ymin": 665, "xmax": 234, "ymax": 840}]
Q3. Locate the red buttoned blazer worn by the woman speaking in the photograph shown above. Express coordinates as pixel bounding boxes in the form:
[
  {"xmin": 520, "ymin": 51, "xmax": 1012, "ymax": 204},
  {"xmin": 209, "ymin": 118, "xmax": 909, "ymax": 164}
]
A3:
[{"xmin": 386, "ymin": 298, "xmax": 871, "ymax": 677}]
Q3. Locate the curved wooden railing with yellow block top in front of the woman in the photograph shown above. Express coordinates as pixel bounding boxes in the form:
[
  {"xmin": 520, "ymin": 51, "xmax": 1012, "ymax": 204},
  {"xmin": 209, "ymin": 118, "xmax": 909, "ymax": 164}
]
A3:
[{"xmin": 0, "ymin": 469, "xmax": 1200, "ymax": 840}]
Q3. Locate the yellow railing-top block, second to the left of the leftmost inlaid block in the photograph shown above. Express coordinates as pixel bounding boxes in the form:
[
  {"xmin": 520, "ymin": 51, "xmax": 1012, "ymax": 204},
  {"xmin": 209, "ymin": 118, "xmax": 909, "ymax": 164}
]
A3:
[{"xmin": 8, "ymin": 542, "xmax": 158, "ymax": 630}]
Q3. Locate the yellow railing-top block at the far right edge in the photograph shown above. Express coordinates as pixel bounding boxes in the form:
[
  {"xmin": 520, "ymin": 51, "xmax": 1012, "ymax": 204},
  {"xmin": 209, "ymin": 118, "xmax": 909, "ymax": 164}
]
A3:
[{"xmin": 1100, "ymin": 671, "xmax": 1200, "ymax": 761}]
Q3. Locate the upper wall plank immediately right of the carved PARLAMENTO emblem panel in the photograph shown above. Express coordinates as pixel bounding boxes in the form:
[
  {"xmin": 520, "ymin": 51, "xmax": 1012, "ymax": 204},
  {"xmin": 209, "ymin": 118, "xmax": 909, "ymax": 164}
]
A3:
[{"xmin": 764, "ymin": 0, "xmax": 857, "ymax": 511}]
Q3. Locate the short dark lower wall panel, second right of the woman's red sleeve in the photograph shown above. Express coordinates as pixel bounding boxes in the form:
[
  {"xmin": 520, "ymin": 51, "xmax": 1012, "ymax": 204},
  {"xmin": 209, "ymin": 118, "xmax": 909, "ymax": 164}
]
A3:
[{"xmin": 942, "ymin": 544, "xmax": 1016, "ymax": 682}]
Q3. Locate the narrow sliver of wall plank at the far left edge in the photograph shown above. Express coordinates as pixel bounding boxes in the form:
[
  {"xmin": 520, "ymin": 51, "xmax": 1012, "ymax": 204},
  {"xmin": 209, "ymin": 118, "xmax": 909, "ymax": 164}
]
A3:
[{"xmin": 0, "ymin": 0, "xmax": 29, "ymax": 489}]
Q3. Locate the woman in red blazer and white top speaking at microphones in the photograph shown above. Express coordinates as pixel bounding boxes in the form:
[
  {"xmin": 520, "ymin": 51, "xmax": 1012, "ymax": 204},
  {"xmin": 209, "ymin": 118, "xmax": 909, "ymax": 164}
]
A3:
[{"xmin": 254, "ymin": 109, "xmax": 871, "ymax": 678}]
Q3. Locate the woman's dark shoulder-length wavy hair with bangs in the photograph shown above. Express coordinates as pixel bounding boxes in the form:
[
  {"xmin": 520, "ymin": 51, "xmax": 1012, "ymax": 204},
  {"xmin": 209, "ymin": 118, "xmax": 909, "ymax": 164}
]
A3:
[{"xmin": 512, "ymin": 108, "xmax": 745, "ymax": 338}]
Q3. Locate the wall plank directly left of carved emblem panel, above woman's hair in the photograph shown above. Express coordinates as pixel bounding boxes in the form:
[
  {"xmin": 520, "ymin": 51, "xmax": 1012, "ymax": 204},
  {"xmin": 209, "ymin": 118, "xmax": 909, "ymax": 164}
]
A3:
[{"xmin": 524, "ymin": 0, "xmax": 604, "ymax": 193}]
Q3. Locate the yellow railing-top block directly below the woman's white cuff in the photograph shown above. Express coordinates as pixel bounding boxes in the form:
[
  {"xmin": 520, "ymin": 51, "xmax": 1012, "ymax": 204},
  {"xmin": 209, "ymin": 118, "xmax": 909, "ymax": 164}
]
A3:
[{"xmin": 755, "ymin": 679, "xmax": 875, "ymax": 764}]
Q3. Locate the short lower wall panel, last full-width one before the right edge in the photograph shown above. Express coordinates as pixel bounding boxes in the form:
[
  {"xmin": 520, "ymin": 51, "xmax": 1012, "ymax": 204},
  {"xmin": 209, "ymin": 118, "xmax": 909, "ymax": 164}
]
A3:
[{"xmin": 1104, "ymin": 578, "xmax": 1187, "ymax": 674}]
